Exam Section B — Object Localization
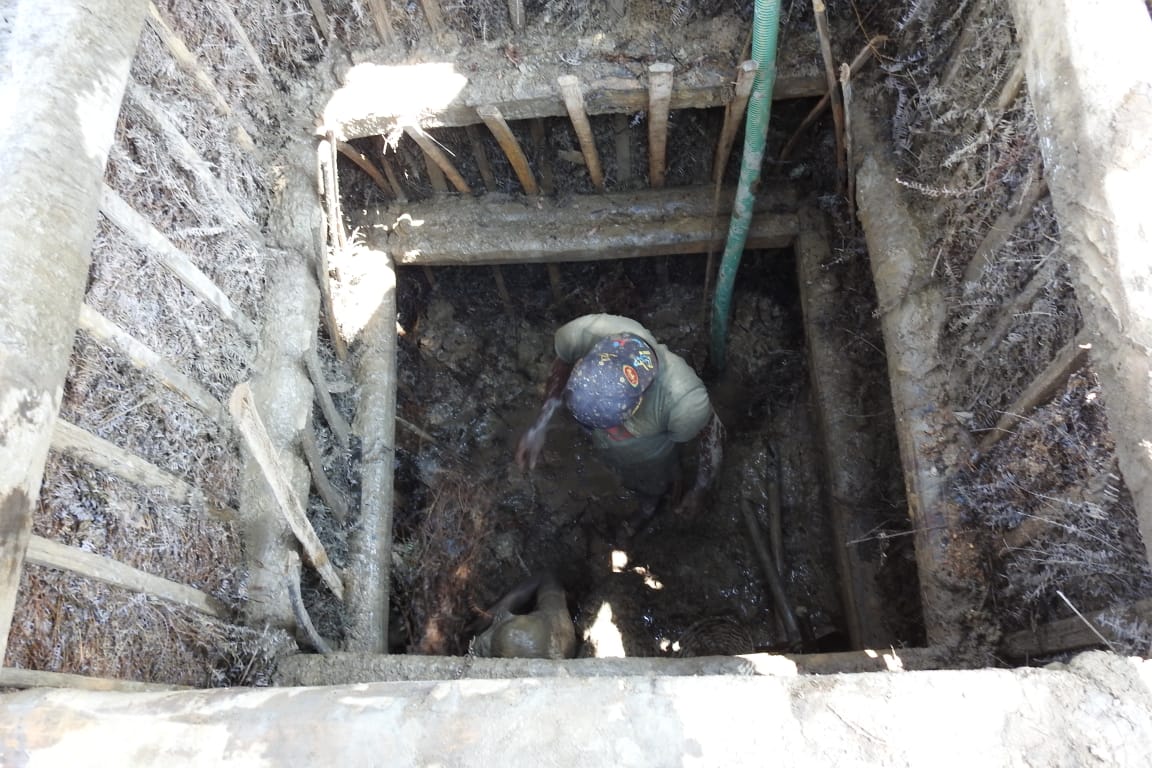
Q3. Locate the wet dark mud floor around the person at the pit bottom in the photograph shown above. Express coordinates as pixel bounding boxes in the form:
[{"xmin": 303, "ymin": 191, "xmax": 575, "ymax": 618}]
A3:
[{"xmin": 377, "ymin": 251, "xmax": 880, "ymax": 656}]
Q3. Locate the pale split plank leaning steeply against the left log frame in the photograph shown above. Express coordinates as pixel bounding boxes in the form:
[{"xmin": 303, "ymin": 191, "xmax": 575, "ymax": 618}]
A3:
[{"xmin": 228, "ymin": 382, "xmax": 344, "ymax": 600}]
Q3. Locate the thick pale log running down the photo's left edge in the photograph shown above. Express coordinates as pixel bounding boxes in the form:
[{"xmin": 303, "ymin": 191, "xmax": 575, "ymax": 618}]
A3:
[{"xmin": 0, "ymin": 0, "xmax": 147, "ymax": 663}]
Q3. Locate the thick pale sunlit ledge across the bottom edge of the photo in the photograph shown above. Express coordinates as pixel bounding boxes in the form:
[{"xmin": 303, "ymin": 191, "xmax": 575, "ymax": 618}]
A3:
[{"xmin": 0, "ymin": 653, "xmax": 1152, "ymax": 767}]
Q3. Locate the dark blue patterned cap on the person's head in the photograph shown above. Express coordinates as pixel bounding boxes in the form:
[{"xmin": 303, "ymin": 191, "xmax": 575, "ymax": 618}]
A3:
[{"xmin": 564, "ymin": 333, "xmax": 658, "ymax": 429}]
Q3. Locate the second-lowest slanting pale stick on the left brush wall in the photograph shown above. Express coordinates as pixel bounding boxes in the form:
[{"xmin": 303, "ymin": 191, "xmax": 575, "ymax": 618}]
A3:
[{"xmin": 52, "ymin": 419, "xmax": 240, "ymax": 523}]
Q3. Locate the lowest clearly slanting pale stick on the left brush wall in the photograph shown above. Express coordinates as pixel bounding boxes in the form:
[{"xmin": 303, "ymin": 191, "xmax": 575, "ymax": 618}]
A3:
[{"xmin": 28, "ymin": 535, "xmax": 232, "ymax": 622}]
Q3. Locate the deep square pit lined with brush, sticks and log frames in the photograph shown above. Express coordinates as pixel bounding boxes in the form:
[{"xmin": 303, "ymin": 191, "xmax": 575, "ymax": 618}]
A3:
[{"xmin": 5, "ymin": 0, "xmax": 1152, "ymax": 704}]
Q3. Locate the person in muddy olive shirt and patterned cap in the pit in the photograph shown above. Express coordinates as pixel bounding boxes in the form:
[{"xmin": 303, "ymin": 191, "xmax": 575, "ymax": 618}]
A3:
[{"xmin": 516, "ymin": 314, "xmax": 723, "ymax": 537}]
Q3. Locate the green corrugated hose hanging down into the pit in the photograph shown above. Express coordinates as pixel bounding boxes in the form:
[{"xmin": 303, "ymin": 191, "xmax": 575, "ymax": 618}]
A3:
[{"xmin": 711, "ymin": 0, "xmax": 780, "ymax": 371}]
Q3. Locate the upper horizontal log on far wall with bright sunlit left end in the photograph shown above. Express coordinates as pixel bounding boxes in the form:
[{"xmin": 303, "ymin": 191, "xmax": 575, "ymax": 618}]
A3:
[{"xmin": 321, "ymin": 28, "xmax": 827, "ymax": 140}]
